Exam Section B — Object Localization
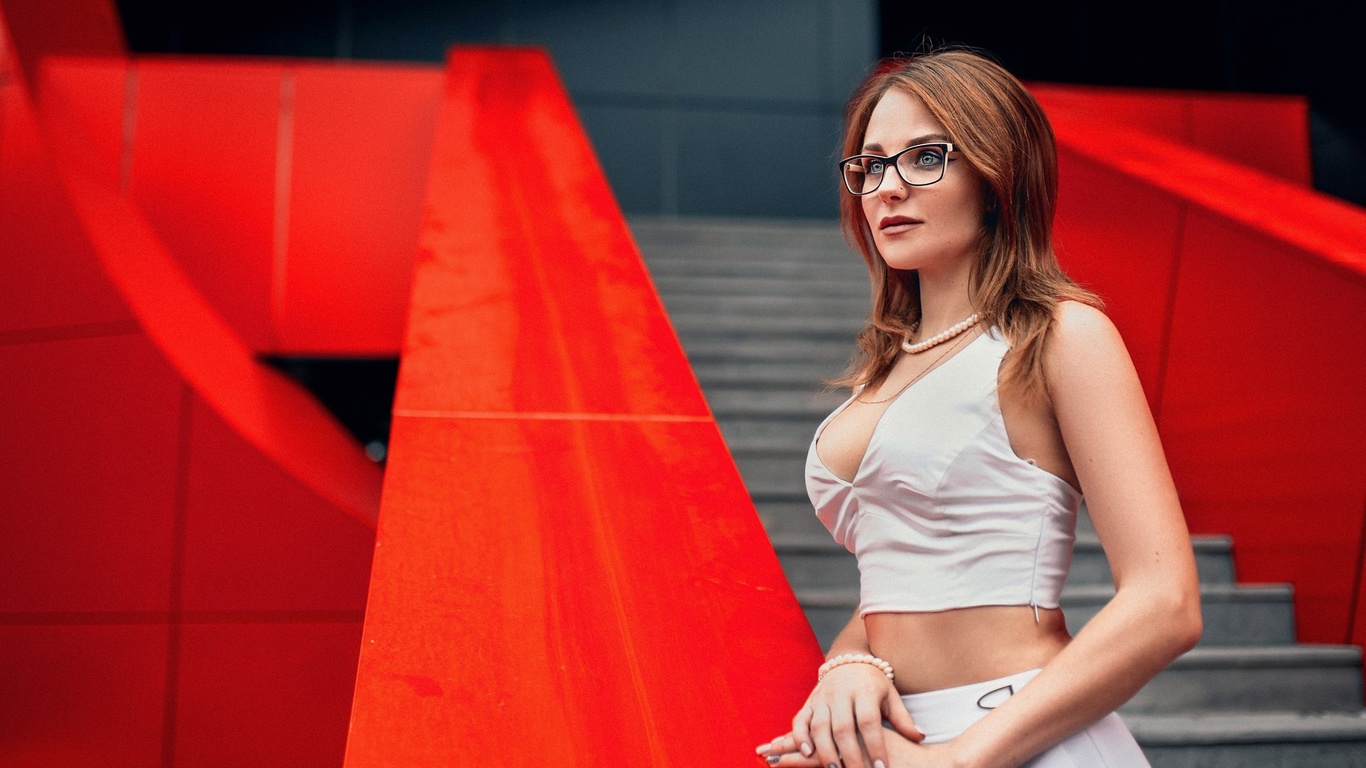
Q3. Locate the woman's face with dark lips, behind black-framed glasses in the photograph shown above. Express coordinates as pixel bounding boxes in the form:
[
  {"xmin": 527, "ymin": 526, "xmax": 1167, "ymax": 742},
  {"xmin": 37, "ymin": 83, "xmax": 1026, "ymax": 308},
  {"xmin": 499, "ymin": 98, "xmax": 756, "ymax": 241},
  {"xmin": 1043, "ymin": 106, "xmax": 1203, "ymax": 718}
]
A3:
[{"xmin": 861, "ymin": 87, "xmax": 986, "ymax": 276}]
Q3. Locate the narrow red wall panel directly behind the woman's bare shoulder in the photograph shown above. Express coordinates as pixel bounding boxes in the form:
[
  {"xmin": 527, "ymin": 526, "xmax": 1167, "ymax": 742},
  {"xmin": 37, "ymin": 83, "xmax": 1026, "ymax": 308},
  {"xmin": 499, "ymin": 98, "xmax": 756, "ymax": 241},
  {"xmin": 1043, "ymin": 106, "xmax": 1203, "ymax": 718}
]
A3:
[{"xmin": 1055, "ymin": 148, "xmax": 1182, "ymax": 407}]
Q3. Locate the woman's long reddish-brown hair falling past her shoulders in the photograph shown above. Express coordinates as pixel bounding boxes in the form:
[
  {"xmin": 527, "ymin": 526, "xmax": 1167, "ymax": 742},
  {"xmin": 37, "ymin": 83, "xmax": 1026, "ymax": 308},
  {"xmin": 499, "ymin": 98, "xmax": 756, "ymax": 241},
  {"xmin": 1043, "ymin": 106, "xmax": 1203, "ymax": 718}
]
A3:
[{"xmin": 832, "ymin": 49, "xmax": 1101, "ymax": 396}]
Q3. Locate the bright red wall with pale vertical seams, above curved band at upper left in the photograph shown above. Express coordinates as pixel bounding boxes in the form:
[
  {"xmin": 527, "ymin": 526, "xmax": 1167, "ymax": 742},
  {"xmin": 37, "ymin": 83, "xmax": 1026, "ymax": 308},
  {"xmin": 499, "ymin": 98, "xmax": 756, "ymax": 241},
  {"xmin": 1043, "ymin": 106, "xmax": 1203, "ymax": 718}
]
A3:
[{"xmin": 29, "ymin": 57, "xmax": 441, "ymax": 357}]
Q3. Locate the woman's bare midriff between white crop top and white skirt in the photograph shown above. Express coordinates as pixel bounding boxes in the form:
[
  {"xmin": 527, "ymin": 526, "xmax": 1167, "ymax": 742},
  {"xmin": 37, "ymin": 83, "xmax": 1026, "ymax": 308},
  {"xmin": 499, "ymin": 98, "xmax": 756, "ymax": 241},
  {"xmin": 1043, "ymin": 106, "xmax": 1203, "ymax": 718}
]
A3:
[{"xmin": 863, "ymin": 605, "xmax": 1071, "ymax": 694}]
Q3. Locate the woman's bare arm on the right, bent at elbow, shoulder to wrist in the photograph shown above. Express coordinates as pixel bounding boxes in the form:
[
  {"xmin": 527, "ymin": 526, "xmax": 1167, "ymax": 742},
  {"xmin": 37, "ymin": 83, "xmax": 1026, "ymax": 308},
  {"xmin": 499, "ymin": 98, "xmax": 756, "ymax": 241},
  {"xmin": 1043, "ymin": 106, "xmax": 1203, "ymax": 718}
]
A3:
[{"xmin": 948, "ymin": 302, "xmax": 1201, "ymax": 768}]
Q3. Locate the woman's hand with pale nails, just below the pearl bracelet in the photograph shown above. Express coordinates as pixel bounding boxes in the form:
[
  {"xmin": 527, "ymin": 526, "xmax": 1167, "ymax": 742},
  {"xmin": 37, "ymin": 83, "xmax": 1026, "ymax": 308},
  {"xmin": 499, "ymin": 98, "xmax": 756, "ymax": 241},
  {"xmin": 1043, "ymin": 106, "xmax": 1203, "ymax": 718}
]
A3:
[{"xmin": 758, "ymin": 663, "xmax": 925, "ymax": 768}]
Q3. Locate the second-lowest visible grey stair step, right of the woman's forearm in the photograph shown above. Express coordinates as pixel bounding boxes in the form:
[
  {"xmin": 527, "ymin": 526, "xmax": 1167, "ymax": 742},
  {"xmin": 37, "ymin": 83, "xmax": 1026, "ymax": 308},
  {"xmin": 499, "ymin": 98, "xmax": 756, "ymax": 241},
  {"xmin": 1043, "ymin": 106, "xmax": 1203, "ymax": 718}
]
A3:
[{"xmin": 1121, "ymin": 645, "xmax": 1362, "ymax": 715}]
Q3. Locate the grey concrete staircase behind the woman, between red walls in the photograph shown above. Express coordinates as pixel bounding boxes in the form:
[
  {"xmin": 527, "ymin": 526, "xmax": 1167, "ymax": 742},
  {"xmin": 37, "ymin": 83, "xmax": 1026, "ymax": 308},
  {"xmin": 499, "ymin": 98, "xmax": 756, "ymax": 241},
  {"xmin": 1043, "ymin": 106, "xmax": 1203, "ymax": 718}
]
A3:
[{"xmin": 631, "ymin": 217, "xmax": 1366, "ymax": 768}]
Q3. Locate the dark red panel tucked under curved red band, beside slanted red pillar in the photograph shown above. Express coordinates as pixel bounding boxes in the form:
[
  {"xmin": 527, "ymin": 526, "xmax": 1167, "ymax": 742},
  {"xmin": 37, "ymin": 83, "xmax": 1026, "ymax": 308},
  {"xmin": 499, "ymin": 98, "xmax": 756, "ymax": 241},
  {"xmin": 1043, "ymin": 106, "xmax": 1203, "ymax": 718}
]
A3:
[{"xmin": 183, "ymin": 399, "xmax": 374, "ymax": 609}]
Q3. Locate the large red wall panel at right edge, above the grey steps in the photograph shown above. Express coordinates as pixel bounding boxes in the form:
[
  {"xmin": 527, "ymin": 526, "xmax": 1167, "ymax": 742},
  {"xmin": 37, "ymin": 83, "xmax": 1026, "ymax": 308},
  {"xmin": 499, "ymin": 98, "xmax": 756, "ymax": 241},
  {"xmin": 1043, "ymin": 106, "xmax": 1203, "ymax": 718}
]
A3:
[{"xmin": 1161, "ymin": 210, "xmax": 1366, "ymax": 642}]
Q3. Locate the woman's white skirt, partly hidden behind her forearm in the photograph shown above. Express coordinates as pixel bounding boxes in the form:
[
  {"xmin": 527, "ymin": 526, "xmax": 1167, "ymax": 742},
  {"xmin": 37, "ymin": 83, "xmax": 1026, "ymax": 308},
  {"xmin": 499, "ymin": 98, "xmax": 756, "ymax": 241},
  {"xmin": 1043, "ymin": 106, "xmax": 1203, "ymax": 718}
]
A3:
[{"xmin": 902, "ymin": 670, "xmax": 1149, "ymax": 768}]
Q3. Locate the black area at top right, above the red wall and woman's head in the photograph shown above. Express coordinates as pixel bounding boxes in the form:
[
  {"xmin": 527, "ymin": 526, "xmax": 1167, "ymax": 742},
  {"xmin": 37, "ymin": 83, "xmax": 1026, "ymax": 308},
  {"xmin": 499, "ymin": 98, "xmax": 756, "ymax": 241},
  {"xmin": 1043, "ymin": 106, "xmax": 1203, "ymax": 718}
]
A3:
[{"xmin": 881, "ymin": 0, "xmax": 1366, "ymax": 205}]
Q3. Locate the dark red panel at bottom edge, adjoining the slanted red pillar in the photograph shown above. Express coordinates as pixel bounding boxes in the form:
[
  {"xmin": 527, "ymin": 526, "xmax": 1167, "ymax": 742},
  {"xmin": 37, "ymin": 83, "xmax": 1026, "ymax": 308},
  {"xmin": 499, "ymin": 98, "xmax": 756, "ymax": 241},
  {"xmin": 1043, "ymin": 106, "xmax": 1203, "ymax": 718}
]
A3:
[{"xmin": 175, "ymin": 623, "xmax": 360, "ymax": 768}]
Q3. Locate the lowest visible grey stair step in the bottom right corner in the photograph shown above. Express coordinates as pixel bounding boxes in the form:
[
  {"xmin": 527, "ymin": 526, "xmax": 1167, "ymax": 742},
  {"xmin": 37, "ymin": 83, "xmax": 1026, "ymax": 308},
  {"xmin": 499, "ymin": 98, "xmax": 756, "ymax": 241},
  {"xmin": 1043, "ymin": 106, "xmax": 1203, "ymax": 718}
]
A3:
[{"xmin": 1121, "ymin": 712, "xmax": 1366, "ymax": 768}]
